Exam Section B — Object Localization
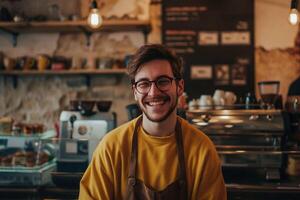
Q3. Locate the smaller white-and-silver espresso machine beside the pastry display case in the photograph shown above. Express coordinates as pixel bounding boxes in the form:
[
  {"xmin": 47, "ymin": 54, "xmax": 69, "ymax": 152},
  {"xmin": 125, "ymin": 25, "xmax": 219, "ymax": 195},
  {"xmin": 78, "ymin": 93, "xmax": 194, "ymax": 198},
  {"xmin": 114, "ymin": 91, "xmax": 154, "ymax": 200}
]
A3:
[{"xmin": 57, "ymin": 101, "xmax": 117, "ymax": 172}]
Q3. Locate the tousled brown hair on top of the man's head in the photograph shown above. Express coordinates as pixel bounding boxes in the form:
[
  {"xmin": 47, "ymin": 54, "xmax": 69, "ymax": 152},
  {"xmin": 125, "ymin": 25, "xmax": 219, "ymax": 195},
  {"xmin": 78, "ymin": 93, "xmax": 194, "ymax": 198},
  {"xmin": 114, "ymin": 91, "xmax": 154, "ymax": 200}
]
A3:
[{"xmin": 127, "ymin": 44, "xmax": 183, "ymax": 83}]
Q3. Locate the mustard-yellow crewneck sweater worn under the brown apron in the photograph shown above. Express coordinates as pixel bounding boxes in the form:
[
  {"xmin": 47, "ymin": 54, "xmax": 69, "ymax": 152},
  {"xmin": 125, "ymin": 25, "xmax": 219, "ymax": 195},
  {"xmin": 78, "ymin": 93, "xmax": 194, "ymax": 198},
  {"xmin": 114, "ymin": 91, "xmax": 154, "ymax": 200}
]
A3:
[{"xmin": 79, "ymin": 118, "xmax": 226, "ymax": 200}]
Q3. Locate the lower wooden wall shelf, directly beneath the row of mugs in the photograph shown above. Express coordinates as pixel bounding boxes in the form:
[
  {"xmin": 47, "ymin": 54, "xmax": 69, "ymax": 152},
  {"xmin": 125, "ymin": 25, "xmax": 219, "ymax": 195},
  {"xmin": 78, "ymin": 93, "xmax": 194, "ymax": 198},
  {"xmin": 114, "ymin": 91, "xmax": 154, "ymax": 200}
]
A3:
[{"xmin": 0, "ymin": 69, "xmax": 127, "ymax": 76}]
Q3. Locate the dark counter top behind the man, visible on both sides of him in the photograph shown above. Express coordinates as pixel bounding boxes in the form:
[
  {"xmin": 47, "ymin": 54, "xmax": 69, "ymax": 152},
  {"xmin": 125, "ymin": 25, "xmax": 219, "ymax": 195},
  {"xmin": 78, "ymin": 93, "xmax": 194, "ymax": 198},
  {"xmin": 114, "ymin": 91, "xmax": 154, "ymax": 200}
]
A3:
[{"xmin": 0, "ymin": 178, "xmax": 300, "ymax": 200}]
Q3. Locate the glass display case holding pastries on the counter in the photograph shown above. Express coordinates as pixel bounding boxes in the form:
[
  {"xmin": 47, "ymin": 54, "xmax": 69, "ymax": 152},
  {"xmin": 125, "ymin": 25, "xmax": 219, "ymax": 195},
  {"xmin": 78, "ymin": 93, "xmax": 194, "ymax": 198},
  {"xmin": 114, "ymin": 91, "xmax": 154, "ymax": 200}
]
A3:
[{"xmin": 0, "ymin": 130, "xmax": 57, "ymax": 187}]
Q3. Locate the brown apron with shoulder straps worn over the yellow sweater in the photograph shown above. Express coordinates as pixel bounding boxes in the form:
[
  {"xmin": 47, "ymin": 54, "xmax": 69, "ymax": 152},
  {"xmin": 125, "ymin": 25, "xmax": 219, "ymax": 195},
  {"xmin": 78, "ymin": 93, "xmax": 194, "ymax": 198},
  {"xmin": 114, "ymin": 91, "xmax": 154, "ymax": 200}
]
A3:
[{"xmin": 127, "ymin": 117, "xmax": 187, "ymax": 200}]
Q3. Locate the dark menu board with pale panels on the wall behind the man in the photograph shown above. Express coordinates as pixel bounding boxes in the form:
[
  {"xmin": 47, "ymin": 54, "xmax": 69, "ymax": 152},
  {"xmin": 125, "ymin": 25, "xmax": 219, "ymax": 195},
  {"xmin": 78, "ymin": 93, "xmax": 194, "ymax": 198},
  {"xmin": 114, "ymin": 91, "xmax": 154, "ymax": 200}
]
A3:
[{"xmin": 162, "ymin": 0, "xmax": 255, "ymax": 98}]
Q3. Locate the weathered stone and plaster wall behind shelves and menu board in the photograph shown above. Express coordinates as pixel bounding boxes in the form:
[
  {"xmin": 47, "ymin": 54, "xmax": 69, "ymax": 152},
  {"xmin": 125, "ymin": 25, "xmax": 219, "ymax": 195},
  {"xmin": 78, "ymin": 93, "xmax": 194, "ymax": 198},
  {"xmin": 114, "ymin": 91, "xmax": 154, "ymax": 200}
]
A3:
[{"xmin": 0, "ymin": 0, "xmax": 300, "ymax": 199}]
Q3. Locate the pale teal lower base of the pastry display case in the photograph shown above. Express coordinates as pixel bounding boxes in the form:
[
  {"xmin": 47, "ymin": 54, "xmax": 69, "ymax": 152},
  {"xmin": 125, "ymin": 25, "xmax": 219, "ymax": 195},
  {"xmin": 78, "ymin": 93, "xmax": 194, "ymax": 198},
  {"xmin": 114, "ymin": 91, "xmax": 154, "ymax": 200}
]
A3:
[{"xmin": 0, "ymin": 159, "xmax": 56, "ymax": 187}]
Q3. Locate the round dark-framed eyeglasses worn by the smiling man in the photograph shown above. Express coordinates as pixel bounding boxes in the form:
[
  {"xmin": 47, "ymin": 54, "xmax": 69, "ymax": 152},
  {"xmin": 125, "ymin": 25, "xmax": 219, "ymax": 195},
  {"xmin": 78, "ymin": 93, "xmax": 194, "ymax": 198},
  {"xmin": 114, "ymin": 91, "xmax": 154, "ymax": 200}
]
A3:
[{"xmin": 132, "ymin": 76, "xmax": 178, "ymax": 94}]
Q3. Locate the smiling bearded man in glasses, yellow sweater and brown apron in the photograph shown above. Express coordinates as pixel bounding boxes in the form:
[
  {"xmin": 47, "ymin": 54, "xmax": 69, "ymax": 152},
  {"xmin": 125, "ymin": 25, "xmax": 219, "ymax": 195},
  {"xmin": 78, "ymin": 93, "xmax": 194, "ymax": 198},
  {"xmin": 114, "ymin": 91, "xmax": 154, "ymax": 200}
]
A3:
[{"xmin": 79, "ymin": 45, "xmax": 226, "ymax": 200}]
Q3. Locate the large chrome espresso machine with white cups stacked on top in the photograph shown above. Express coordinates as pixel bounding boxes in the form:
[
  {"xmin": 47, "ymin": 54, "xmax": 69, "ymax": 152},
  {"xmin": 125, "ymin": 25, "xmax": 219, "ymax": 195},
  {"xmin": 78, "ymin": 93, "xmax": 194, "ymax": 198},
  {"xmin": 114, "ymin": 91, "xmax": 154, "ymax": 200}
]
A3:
[{"xmin": 187, "ymin": 109, "xmax": 286, "ymax": 181}]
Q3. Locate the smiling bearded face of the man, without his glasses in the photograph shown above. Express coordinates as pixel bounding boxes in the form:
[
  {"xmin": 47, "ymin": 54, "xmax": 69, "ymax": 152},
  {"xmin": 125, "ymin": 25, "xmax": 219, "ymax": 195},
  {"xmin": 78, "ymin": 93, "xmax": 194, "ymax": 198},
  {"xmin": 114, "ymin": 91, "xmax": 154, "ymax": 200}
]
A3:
[{"xmin": 133, "ymin": 60, "xmax": 184, "ymax": 122}]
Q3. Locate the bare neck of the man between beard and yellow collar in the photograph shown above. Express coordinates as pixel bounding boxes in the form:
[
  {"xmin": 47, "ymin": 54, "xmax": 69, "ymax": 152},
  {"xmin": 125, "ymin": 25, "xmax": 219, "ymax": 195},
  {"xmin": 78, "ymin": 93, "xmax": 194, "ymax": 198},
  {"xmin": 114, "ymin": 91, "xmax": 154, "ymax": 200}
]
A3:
[{"xmin": 143, "ymin": 112, "xmax": 177, "ymax": 136}]
